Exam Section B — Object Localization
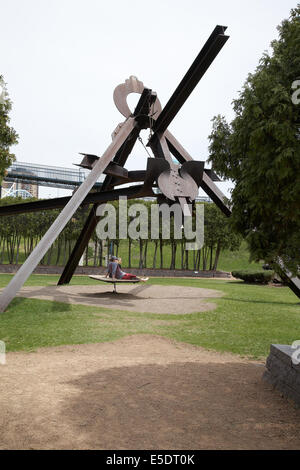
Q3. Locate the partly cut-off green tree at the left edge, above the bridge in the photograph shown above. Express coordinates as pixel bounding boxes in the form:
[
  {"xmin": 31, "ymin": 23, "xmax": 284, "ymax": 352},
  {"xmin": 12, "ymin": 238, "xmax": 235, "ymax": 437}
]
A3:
[{"xmin": 0, "ymin": 75, "xmax": 18, "ymax": 184}]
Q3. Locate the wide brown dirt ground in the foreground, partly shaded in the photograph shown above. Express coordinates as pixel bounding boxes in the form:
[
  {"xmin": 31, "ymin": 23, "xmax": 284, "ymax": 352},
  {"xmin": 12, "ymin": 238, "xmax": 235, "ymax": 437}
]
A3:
[{"xmin": 0, "ymin": 335, "xmax": 300, "ymax": 449}]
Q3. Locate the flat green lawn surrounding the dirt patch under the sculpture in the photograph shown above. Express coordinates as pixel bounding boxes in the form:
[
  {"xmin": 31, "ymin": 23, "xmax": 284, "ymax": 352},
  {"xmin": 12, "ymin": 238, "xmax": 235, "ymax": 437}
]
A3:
[{"xmin": 0, "ymin": 275, "xmax": 300, "ymax": 358}]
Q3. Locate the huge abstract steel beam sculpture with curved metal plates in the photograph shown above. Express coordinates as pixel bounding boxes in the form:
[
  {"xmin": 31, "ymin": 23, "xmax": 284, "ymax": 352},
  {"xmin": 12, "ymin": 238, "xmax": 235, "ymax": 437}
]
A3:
[{"xmin": 0, "ymin": 26, "xmax": 300, "ymax": 312}]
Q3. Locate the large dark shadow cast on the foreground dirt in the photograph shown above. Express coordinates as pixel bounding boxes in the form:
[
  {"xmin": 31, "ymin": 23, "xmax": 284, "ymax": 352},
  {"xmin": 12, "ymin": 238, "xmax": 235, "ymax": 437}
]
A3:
[{"xmin": 61, "ymin": 362, "xmax": 300, "ymax": 450}]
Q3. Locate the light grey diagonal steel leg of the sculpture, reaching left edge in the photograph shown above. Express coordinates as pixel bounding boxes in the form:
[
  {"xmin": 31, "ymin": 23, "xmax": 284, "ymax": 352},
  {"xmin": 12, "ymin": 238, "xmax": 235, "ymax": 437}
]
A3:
[{"xmin": 0, "ymin": 117, "xmax": 136, "ymax": 312}]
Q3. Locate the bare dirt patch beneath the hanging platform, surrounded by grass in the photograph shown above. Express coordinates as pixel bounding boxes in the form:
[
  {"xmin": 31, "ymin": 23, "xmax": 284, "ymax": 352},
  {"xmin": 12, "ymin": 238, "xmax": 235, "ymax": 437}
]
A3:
[{"xmin": 19, "ymin": 281, "xmax": 223, "ymax": 315}]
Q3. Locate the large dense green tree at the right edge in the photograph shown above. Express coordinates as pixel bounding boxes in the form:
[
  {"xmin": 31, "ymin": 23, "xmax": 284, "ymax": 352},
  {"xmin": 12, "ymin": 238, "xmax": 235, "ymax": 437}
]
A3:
[{"xmin": 209, "ymin": 4, "xmax": 300, "ymax": 274}]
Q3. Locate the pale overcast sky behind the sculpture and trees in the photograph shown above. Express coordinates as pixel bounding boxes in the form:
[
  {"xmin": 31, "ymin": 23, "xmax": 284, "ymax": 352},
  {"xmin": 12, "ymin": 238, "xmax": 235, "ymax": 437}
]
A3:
[{"xmin": 0, "ymin": 0, "xmax": 297, "ymax": 196}]
